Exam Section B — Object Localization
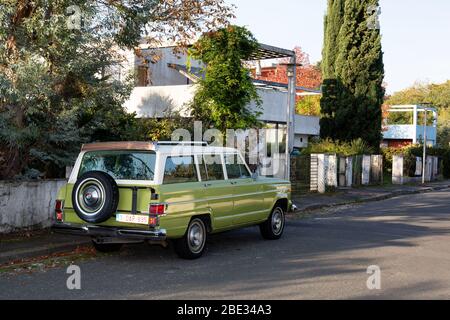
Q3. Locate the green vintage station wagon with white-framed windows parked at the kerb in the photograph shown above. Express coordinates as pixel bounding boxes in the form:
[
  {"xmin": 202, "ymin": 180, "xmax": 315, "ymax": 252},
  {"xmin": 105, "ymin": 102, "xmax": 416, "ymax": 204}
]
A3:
[{"xmin": 53, "ymin": 142, "xmax": 291, "ymax": 259}]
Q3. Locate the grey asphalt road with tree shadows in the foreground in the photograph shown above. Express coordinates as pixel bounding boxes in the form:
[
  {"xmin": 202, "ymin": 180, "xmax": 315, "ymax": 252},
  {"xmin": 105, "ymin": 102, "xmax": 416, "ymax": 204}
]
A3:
[{"xmin": 0, "ymin": 190, "xmax": 450, "ymax": 300}]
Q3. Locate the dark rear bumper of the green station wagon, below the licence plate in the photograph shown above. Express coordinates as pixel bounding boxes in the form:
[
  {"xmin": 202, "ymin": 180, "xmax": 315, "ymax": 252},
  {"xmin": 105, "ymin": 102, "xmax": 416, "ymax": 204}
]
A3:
[{"xmin": 52, "ymin": 223, "xmax": 167, "ymax": 241}]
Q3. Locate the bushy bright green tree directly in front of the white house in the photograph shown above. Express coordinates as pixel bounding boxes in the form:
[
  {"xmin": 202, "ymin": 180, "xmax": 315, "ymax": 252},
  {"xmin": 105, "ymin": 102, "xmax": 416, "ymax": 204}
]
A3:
[{"xmin": 189, "ymin": 25, "xmax": 261, "ymax": 134}]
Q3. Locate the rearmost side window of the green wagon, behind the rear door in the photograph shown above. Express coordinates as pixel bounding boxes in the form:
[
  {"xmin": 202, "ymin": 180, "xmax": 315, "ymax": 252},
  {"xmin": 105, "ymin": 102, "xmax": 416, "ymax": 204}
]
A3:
[{"xmin": 164, "ymin": 156, "xmax": 198, "ymax": 184}]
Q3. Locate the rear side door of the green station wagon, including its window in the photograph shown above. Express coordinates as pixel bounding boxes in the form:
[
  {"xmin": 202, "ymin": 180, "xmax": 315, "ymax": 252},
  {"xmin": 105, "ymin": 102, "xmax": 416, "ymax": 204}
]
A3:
[{"xmin": 197, "ymin": 154, "xmax": 233, "ymax": 230}]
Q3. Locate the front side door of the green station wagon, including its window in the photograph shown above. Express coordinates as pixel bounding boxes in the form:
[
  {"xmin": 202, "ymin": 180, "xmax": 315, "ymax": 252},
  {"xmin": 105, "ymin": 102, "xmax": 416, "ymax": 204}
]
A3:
[{"xmin": 225, "ymin": 153, "xmax": 264, "ymax": 225}]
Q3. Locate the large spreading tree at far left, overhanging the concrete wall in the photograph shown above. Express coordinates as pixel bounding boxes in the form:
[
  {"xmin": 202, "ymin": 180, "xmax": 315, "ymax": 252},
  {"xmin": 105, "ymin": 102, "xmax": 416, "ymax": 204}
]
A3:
[{"xmin": 0, "ymin": 0, "xmax": 232, "ymax": 179}]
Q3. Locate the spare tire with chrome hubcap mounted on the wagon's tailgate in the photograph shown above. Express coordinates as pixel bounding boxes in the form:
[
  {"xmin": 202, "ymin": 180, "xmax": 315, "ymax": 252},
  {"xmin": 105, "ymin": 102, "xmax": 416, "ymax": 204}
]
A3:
[{"xmin": 72, "ymin": 171, "xmax": 119, "ymax": 223}]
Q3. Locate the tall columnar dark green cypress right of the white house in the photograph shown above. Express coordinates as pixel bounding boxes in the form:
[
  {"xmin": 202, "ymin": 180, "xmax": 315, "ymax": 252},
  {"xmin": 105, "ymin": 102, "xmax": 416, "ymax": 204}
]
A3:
[{"xmin": 321, "ymin": 0, "xmax": 384, "ymax": 148}]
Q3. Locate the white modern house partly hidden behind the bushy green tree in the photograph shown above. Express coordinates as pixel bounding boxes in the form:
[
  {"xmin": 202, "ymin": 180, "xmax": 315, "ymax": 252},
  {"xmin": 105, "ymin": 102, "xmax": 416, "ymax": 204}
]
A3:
[{"xmin": 121, "ymin": 45, "xmax": 320, "ymax": 177}]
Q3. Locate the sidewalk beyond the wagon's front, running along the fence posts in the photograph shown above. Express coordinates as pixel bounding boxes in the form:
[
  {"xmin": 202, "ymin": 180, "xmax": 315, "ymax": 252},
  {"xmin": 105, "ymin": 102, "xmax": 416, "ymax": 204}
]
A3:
[{"xmin": 292, "ymin": 180, "xmax": 450, "ymax": 213}]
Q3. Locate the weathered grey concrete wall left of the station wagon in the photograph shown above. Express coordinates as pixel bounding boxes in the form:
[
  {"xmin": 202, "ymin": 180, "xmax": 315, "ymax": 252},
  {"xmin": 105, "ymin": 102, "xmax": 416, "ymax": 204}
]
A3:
[{"xmin": 0, "ymin": 180, "xmax": 66, "ymax": 234}]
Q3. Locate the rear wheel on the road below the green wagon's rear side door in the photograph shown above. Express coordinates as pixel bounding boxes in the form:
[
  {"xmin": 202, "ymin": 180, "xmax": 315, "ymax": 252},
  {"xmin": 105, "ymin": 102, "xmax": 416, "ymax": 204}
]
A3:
[{"xmin": 174, "ymin": 218, "xmax": 208, "ymax": 260}]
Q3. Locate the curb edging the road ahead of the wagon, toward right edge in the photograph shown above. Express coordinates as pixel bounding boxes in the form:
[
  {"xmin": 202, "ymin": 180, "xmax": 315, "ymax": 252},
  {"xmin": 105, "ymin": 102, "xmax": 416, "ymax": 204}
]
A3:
[{"xmin": 291, "ymin": 185, "xmax": 450, "ymax": 215}]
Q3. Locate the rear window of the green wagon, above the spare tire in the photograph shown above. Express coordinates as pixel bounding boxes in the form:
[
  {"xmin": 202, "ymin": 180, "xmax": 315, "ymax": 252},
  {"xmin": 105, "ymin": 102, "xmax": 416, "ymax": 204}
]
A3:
[{"xmin": 78, "ymin": 151, "xmax": 156, "ymax": 180}]
